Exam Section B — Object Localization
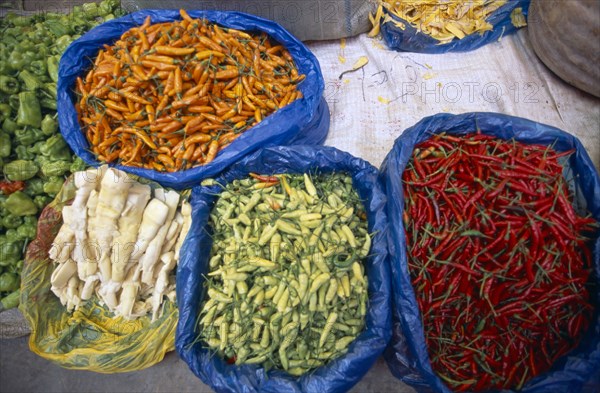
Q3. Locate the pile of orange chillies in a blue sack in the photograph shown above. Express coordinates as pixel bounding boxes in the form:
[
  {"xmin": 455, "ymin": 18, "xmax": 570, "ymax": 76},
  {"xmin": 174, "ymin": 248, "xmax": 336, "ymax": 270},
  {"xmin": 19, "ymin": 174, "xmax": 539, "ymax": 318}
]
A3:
[{"xmin": 76, "ymin": 10, "xmax": 305, "ymax": 172}]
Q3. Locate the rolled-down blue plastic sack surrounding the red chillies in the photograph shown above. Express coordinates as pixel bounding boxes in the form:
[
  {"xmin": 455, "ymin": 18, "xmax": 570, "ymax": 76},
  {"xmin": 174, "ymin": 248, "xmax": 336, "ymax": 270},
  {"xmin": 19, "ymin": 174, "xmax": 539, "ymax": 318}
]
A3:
[{"xmin": 381, "ymin": 113, "xmax": 600, "ymax": 393}]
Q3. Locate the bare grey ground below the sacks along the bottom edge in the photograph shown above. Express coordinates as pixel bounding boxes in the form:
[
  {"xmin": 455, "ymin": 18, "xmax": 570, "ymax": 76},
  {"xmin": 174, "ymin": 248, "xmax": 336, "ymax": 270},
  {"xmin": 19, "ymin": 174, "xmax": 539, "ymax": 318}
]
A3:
[{"xmin": 0, "ymin": 337, "xmax": 414, "ymax": 393}]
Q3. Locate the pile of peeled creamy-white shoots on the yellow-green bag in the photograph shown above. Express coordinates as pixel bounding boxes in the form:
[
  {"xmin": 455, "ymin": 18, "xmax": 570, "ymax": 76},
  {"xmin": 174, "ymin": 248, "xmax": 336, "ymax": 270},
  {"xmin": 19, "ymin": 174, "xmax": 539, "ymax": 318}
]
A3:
[{"xmin": 49, "ymin": 166, "xmax": 191, "ymax": 320}]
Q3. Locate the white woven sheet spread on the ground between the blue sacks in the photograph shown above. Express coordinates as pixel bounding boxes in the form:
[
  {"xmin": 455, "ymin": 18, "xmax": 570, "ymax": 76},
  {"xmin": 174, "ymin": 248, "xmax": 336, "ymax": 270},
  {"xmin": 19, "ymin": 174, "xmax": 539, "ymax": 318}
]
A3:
[{"xmin": 308, "ymin": 29, "xmax": 600, "ymax": 169}]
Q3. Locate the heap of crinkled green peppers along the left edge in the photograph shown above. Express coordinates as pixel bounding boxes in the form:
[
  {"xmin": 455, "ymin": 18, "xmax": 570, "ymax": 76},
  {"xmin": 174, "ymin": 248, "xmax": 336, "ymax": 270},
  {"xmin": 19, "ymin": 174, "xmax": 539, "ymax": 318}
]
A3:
[{"xmin": 0, "ymin": 0, "xmax": 122, "ymax": 311}]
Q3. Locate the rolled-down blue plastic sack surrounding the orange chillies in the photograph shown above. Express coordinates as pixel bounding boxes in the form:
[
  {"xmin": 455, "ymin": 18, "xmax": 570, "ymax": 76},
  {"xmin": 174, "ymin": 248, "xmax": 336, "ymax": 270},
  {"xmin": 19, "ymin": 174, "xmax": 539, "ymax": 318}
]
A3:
[{"xmin": 57, "ymin": 10, "xmax": 329, "ymax": 189}]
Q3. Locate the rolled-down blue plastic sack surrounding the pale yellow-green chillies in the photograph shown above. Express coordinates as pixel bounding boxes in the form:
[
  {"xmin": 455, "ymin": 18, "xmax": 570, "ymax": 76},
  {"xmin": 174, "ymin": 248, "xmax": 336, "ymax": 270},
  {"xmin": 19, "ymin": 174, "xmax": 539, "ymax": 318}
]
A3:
[{"xmin": 175, "ymin": 146, "xmax": 391, "ymax": 392}]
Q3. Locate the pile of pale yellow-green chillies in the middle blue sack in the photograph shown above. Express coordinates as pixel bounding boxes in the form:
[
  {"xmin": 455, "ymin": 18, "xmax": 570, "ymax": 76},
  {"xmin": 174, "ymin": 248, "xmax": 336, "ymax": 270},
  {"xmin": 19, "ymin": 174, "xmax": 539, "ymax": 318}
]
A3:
[{"xmin": 199, "ymin": 174, "xmax": 371, "ymax": 375}]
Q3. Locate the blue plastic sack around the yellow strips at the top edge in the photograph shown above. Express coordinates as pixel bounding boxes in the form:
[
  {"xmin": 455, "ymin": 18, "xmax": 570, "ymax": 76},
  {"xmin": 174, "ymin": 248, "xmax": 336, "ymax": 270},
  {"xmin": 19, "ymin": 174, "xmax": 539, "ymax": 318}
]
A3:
[{"xmin": 381, "ymin": 0, "xmax": 531, "ymax": 53}]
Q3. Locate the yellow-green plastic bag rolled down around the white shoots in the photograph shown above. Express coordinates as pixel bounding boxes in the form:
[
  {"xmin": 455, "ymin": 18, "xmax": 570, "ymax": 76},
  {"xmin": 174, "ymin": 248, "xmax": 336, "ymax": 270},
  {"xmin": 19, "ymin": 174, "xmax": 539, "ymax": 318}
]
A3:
[{"xmin": 19, "ymin": 176, "xmax": 179, "ymax": 373}]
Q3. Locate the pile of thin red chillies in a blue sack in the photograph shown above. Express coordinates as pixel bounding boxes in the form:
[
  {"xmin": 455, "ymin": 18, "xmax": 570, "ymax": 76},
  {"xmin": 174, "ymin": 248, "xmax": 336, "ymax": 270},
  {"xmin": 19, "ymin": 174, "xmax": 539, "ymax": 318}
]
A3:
[{"xmin": 402, "ymin": 133, "xmax": 598, "ymax": 391}]
